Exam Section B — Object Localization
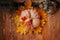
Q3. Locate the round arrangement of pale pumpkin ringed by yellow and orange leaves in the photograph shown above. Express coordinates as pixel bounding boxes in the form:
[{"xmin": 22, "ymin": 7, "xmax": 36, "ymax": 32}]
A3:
[{"xmin": 14, "ymin": 2, "xmax": 47, "ymax": 35}]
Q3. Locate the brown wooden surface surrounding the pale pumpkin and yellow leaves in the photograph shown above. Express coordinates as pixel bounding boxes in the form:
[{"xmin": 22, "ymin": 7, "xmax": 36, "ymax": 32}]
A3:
[{"xmin": 0, "ymin": 9, "xmax": 60, "ymax": 40}]
